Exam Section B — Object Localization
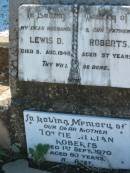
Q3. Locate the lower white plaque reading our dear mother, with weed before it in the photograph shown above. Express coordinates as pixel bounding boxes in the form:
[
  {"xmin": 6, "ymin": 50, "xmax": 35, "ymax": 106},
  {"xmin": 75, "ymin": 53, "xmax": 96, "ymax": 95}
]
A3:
[{"xmin": 24, "ymin": 111, "xmax": 130, "ymax": 169}]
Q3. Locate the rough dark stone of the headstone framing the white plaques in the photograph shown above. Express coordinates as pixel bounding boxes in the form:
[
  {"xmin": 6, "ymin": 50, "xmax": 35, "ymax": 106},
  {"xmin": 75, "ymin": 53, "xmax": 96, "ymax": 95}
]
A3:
[{"xmin": 10, "ymin": 0, "xmax": 130, "ymax": 153}]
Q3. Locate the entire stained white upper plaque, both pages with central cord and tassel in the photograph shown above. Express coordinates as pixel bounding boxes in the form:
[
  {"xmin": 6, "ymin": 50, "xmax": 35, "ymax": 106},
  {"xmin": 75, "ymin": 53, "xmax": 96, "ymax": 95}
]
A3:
[{"xmin": 19, "ymin": 5, "xmax": 130, "ymax": 88}]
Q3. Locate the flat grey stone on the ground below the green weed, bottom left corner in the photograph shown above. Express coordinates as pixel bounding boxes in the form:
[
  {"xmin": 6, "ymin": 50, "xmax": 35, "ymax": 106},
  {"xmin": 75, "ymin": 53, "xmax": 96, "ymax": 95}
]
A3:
[{"xmin": 3, "ymin": 160, "xmax": 50, "ymax": 173}]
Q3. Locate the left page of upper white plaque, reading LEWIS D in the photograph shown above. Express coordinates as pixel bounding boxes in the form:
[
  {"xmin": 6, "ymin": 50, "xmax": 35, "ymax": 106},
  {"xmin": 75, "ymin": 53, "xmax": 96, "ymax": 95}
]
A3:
[{"xmin": 19, "ymin": 5, "xmax": 73, "ymax": 83}]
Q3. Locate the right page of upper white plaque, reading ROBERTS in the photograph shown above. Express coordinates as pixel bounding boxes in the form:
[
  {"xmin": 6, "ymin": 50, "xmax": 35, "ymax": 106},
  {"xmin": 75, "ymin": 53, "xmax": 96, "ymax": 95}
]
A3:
[{"xmin": 78, "ymin": 6, "xmax": 130, "ymax": 88}]
